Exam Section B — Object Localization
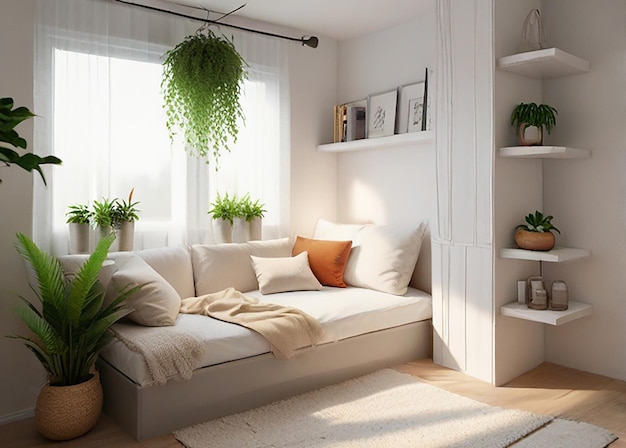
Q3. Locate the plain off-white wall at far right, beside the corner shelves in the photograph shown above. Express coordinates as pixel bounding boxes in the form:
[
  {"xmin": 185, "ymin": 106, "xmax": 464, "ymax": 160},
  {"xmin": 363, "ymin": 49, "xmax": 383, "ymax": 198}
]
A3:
[{"xmin": 542, "ymin": 0, "xmax": 626, "ymax": 380}]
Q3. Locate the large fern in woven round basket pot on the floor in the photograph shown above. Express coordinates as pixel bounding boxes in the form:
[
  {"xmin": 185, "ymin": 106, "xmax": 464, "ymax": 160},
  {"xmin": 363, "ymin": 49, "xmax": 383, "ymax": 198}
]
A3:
[{"xmin": 9, "ymin": 233, "xmax": 138, "ymax": 440}]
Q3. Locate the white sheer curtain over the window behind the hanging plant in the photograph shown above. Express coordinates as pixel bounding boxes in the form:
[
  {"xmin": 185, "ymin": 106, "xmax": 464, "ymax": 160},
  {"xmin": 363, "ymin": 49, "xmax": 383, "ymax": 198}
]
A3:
[{"xmin": 33, "ymin": 0, "xmax": 290, "ymax": 254}]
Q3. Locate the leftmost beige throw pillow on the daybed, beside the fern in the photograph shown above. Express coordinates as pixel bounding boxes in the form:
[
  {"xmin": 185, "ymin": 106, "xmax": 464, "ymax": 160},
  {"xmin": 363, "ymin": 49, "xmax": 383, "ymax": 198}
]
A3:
[{"xmin": 106, "ymin": 252, "xmax": 180, "ymax": 327}]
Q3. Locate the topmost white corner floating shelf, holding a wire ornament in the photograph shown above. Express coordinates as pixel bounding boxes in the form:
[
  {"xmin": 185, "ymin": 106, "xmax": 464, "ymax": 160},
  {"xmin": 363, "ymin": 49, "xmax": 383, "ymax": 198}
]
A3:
[{"xmin": 497, "ymin": 48, "xmax": 589, "ymax": 79}]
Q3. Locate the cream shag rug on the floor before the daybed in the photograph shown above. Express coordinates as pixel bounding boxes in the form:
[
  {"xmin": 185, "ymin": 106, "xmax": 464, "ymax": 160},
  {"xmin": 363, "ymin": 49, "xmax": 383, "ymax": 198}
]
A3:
[{"xmin": 174, "ymin": 369, "xmax": 616, "ymax": 448}]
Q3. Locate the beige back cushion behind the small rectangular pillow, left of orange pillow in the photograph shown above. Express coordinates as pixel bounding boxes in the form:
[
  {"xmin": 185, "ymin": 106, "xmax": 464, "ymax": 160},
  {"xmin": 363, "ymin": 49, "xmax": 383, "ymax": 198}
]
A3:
[{"xmin": 191, "ymin": 238, "xmax": 292, "ymax": 296}]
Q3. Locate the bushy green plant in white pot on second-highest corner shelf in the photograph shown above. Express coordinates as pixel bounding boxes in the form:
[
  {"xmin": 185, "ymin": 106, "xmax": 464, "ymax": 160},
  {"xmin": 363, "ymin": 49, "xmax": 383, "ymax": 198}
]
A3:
[{"xmin": 511, "ymin": 103, "xmax": 558, "ymax": 146}]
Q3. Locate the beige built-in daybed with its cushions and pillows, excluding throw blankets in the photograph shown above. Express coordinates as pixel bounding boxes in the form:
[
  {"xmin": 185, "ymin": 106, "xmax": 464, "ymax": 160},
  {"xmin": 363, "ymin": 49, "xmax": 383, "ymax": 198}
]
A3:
[{"xmin": 62, "ymin": 220, "xmax": 432, "ymax": 440}]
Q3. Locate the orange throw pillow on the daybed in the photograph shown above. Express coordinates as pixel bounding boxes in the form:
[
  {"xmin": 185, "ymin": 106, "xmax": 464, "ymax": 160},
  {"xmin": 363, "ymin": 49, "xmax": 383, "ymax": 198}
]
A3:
[{"xmin": 292, "ymin": 236, "xmax": 352, "ymax": 288}]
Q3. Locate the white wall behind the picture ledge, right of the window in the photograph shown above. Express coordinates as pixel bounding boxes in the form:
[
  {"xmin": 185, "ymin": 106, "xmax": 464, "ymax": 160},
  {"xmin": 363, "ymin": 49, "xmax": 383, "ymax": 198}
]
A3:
[{"xmin": 334, "ymin": 10, "xmax": 436, "ymax": 291}]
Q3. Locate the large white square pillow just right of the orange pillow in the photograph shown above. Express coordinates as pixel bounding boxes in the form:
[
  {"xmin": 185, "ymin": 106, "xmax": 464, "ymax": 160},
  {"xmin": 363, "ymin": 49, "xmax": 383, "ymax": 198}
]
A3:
[{"xmin": 343, "ymin": 223, "xmax": 426, "ymax": 295}]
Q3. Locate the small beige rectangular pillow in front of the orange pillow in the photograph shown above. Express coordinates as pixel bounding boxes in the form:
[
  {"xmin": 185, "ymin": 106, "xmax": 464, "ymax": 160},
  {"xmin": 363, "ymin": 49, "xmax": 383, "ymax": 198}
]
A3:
[{"xmin": 250, "ymin": 251, "xmax": 322, "ymax": 294}]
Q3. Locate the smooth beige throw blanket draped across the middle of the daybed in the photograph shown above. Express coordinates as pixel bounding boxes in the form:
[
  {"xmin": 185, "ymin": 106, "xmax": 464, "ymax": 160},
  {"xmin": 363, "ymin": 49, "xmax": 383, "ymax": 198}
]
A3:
[{"xmin": 180, "ymin": 288, "xmax": 322, "ymax": 359}]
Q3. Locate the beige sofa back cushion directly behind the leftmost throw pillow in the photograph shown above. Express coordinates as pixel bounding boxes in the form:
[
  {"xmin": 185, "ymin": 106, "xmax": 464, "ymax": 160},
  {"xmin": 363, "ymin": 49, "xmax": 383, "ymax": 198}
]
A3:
[{"xmin": 135, "ymin": 246, "xmax": 196, "ymax": 299}]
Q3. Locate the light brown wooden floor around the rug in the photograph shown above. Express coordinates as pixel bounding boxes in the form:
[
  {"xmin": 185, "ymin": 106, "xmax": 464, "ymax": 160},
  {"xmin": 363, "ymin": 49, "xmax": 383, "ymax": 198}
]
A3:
[{"xmin": 0, "ymin": 360, "xmax": 626, "ymax": 448}]
